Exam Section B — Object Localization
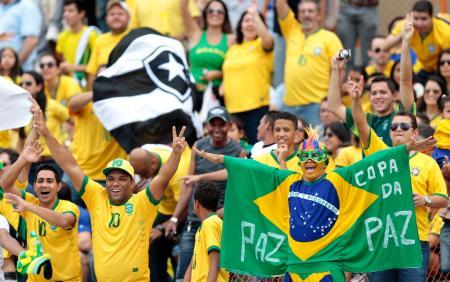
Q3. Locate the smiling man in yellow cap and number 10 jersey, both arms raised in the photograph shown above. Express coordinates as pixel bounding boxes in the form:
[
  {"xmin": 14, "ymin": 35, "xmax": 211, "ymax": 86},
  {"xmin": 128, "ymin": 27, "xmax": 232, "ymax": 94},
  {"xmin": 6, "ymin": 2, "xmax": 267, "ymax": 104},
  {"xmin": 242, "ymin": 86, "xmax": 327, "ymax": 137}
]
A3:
[{"xmin": 33, "ymin": 107, "xmax": 187, "ymax": 281}]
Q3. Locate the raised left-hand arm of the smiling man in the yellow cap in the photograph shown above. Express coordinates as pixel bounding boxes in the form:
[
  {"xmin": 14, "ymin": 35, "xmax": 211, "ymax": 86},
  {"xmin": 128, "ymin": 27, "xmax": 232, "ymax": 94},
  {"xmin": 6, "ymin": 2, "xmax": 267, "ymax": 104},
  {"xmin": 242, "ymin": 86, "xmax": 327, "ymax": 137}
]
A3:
[{"xmin": 33, "ymin": 110, "xmax": 85, "ymax": 192}]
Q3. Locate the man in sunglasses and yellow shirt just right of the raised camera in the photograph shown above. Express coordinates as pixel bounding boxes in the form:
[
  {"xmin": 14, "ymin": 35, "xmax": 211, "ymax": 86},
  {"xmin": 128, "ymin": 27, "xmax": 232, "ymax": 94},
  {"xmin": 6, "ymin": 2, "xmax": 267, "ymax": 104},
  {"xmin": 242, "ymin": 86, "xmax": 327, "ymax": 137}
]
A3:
[{"xmin": 366, "ymin": 36, "xmax": 394, "ymax": 77}]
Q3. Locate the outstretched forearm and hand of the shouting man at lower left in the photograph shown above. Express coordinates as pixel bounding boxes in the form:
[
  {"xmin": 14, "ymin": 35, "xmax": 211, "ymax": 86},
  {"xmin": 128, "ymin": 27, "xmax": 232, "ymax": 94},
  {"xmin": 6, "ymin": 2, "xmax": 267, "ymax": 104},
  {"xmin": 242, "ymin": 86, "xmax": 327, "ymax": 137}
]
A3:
[{"xmin": 5, "ymin": 193, "xmax": 77, "ymax": 230}]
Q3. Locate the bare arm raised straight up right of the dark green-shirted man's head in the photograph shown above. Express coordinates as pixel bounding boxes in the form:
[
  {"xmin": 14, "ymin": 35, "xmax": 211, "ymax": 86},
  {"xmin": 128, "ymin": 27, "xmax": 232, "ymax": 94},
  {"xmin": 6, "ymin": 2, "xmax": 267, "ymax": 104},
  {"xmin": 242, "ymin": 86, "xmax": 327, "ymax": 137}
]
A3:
[{"xmin": 399, "ymin": 13, "xmax": 414, "ymax": 111}]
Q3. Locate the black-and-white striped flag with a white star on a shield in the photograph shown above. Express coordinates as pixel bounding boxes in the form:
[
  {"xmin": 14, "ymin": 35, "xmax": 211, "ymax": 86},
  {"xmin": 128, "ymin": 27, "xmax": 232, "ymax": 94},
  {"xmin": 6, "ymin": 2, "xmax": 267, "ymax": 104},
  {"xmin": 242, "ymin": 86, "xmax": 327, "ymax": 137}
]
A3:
[{"xmin": 94, "ymin": 28, "xmax": 196, "ymax": 152}]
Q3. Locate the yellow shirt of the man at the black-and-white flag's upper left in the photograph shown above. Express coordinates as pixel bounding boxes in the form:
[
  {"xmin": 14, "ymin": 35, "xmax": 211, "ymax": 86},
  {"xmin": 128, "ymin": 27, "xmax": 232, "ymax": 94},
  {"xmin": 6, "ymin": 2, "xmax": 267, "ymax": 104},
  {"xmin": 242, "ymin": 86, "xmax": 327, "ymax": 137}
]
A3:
[{"xmin": 86, "ymin": 30, "xmax": 128, "ymax": 75}]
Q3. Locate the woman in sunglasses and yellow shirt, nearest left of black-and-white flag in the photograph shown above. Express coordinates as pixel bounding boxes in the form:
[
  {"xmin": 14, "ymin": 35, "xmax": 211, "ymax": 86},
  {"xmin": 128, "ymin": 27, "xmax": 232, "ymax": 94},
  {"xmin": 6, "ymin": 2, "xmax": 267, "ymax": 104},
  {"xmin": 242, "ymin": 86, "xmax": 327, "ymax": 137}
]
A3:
[{"xmin": 39, "ymin": 54, "xmax": 81, "ymax": 107}]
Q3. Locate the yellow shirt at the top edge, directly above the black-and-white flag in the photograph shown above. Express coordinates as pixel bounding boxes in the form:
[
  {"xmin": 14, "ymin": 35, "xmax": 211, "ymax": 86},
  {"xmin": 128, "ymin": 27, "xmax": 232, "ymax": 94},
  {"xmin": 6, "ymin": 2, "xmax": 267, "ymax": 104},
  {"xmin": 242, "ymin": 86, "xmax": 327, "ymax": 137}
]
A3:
[{"xmin": 130, "ymin": 0, "xmax": 200, "ymax": 37}]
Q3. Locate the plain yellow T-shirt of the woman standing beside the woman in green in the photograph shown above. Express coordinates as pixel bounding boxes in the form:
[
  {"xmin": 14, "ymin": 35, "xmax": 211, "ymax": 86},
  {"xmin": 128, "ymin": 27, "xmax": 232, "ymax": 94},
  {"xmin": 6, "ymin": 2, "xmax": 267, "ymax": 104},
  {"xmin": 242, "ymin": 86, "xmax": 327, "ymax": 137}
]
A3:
[{"xmin": 222, "ymin": 37, "xmax": 273, "ymax": 113}]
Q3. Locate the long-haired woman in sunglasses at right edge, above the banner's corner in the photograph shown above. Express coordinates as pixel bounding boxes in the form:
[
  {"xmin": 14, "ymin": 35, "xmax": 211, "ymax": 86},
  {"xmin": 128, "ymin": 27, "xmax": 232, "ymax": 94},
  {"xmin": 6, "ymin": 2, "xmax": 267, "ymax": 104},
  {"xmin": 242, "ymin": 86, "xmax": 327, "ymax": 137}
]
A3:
[{"xmin": 417, "ymin": 75, "xmax": 447, "ymax": 127}]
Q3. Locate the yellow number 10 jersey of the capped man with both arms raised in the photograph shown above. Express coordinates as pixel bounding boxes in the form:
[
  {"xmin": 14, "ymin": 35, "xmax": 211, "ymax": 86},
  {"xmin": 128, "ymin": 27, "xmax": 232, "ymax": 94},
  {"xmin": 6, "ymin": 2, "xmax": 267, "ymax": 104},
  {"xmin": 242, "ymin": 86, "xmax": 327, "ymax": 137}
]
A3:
[{"xmin": 79, "ymin": 176, "xmax": 158, "ymax": 282}]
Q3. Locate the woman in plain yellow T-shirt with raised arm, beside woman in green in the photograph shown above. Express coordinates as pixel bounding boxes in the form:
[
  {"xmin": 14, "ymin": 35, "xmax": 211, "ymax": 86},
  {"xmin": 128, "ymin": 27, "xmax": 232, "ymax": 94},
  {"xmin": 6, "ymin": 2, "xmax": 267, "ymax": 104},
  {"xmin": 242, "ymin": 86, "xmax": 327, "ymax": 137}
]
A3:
[{"xmin": 222, "ymin": 4, "xmax": 273, "ymax": 144}]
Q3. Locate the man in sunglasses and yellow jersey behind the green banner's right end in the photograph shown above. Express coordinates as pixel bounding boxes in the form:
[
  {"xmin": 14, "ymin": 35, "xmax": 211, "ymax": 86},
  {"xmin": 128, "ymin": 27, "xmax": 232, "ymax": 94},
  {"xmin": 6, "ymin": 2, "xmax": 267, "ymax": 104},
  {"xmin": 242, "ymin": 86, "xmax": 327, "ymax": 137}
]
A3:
[{"xmin": 350, "ymin": 69, "xmax": 448, "ymax": 282}]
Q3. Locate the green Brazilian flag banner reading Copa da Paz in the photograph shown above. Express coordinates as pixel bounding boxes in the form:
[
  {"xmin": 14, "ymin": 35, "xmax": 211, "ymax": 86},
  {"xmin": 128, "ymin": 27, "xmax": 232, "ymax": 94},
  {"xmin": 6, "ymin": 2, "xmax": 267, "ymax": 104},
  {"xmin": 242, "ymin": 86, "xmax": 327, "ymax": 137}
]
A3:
[{"xmin": 220, "ymin": 145, "xmax": 422, "ymax": 277}]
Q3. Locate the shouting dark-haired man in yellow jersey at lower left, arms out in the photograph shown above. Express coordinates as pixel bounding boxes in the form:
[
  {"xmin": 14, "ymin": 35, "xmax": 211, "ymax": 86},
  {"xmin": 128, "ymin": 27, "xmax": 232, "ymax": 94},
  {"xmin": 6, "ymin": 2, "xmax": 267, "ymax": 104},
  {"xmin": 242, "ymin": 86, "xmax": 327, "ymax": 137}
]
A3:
[{"xmin": 0, "ymin": 140, "xmax": 81, "ymax": 281}]
